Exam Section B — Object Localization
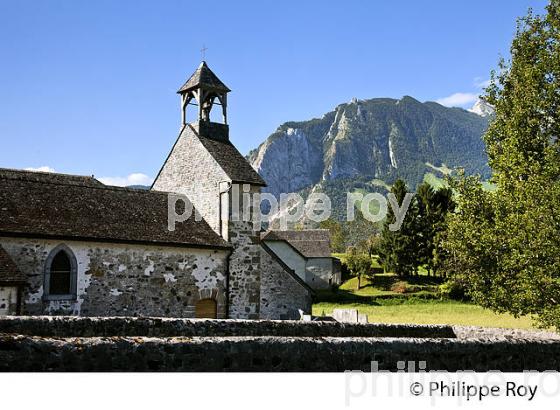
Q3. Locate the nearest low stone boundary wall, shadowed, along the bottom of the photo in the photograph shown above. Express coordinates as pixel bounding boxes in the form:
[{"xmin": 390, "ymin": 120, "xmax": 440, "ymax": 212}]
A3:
[{"xmin": 0, "ymin": 335, "xmax": 560, "ymax": 372}]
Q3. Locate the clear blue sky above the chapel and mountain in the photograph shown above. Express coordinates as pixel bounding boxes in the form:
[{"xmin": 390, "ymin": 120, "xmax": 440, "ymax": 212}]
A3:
[{"xmin": 0, "ymin": 0, "xmax": 546, "ymax": 184}]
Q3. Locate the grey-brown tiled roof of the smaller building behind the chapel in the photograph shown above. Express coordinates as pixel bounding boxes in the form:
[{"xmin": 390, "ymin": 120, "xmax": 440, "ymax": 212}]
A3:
[{"xmin": 262, "ymin": 229, "xmax": 331, "ymax": 258}]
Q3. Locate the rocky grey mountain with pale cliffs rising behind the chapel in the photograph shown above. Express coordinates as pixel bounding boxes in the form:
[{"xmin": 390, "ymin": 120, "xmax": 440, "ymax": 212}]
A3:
[{"xmin": 248, "ymin": 96, "xmax": 489, "ymax": 211}]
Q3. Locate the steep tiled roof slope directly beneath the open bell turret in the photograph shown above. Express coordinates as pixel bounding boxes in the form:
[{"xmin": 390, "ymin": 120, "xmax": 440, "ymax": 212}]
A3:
[{"xmin": 192, "ymin": 124, "xmax": 266, "ymax": 186}]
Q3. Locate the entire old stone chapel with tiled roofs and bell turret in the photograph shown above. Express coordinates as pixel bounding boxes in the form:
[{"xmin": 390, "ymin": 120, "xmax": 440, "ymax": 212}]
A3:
[{"xmin": 0, "ymin": 62, "xmax": 313, "ymax": 319}]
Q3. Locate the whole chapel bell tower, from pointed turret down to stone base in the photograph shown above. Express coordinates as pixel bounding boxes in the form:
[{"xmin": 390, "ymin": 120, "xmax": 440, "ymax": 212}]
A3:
[{"xmin": 152, "ymin": 61, "xmax": 266, "ymax": 319}]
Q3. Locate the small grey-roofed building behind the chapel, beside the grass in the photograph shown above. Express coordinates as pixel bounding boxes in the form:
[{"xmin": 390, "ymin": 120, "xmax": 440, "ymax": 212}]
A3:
[{"xmin": 261, "ymin": 229, "xmax": 341, "ymax": 289}]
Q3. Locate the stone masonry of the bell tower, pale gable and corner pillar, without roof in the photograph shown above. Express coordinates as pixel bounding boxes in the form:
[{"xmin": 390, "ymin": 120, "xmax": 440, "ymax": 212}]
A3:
[{"xmin": 153, "ymin": 126, "xmax": 261, "ymax": 319}]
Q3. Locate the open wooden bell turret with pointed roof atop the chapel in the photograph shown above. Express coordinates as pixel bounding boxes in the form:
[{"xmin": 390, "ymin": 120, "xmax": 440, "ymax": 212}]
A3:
[{"xmin": 177, "ymin": 61, "xmax": 231, "ymax": 138}]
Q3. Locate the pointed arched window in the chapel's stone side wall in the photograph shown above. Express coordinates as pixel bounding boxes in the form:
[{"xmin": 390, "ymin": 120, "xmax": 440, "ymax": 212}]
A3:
[{"xmin": 44, "ymin": 245, "xmax": 77, "ymax": 300}]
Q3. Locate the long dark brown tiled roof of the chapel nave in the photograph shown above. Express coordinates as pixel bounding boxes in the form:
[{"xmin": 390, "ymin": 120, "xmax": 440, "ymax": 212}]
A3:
[{"xmin": 0, "ymin": 169, "xmax": 229, "ymax": 247}]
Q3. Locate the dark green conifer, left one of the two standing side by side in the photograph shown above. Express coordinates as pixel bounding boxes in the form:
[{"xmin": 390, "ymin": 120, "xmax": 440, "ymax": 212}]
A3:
[{"xmin": 379, "ymin": 179, "xmax": 420, "ymax": 276}]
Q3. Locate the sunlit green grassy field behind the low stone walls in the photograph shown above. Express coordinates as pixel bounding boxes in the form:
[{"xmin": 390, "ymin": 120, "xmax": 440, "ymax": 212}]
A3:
[{"xmin": 313, "ymin": 262, "xmax": 533, "ymax": 329}]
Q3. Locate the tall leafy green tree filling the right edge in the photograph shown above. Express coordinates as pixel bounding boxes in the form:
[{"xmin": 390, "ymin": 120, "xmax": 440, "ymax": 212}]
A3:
[{"xmin": 445, "ymin": 0, "xmax": 560, "ymax": 329}]
